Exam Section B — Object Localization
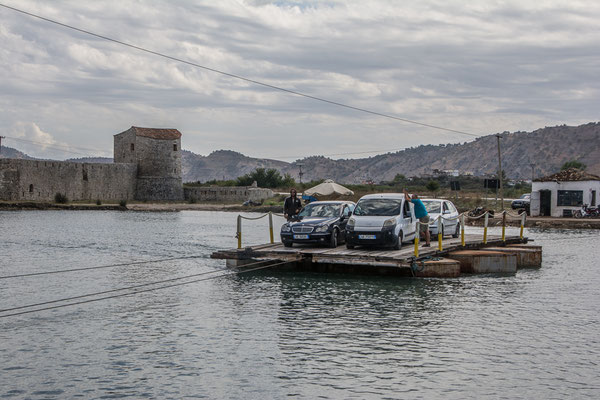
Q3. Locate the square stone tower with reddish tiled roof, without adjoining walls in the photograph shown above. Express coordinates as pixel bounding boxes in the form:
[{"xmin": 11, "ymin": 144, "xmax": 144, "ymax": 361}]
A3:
[{"xmin": 114, "ymin": 126, "xmax": 183, "ymax": 201}]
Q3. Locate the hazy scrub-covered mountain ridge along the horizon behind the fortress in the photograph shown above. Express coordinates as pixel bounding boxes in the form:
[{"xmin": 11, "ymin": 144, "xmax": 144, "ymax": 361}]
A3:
[{"xmin": 0, "ymin": 122, "xmax": 600, "ymax": 183}]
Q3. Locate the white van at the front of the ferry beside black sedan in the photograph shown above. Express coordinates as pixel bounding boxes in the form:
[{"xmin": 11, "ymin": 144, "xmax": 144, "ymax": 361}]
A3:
[{"xmin": 346, "ymin": 193, "xmax": 417, "ymax": 250}]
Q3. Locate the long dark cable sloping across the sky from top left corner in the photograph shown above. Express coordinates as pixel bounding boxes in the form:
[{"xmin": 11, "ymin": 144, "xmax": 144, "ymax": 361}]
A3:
[{"xmin": 0, "ymin": 3, "xmax": 480, "ymax": 137}]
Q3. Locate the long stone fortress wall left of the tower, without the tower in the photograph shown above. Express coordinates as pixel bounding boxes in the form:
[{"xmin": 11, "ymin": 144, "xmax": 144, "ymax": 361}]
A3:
[{"xmin": 0, "ymin": 159, "xmax": 137, "ymax": 202}]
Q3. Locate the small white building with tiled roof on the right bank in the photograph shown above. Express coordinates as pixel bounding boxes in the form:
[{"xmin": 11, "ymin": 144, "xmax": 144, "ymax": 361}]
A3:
[{"xmin": 531, "ymin": 168, "xmax": 600, "ymax": 217}]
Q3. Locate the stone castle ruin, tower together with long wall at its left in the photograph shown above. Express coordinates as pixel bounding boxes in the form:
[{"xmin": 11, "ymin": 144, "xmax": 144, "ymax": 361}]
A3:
[{"xmin": 0, "ymin": 126, "xmax": 183, "ymax": 201}]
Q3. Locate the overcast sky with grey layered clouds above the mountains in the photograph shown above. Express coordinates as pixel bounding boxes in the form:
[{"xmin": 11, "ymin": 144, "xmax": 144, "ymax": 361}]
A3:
[{"xmin": 0, "ymin": 0, "xmax": 600, "ymax": 162}]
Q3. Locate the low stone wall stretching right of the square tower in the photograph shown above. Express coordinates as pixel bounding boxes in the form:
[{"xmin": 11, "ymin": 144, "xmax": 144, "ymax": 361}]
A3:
[{"xmin": 183, "ymin": 186, "xmax": 274, "ymax": 203}]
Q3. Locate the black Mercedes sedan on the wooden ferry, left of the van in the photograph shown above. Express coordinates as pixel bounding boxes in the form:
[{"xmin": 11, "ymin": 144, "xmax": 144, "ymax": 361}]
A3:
[{"xmin": 281, "ymin": 201, "xmax": 355, "ymax": 247}]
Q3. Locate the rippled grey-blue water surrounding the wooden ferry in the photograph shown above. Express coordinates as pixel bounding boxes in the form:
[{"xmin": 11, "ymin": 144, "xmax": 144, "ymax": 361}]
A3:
[{"xmin": 0, "ymin": 211, "xmax": 600, "ymax": 399}]
